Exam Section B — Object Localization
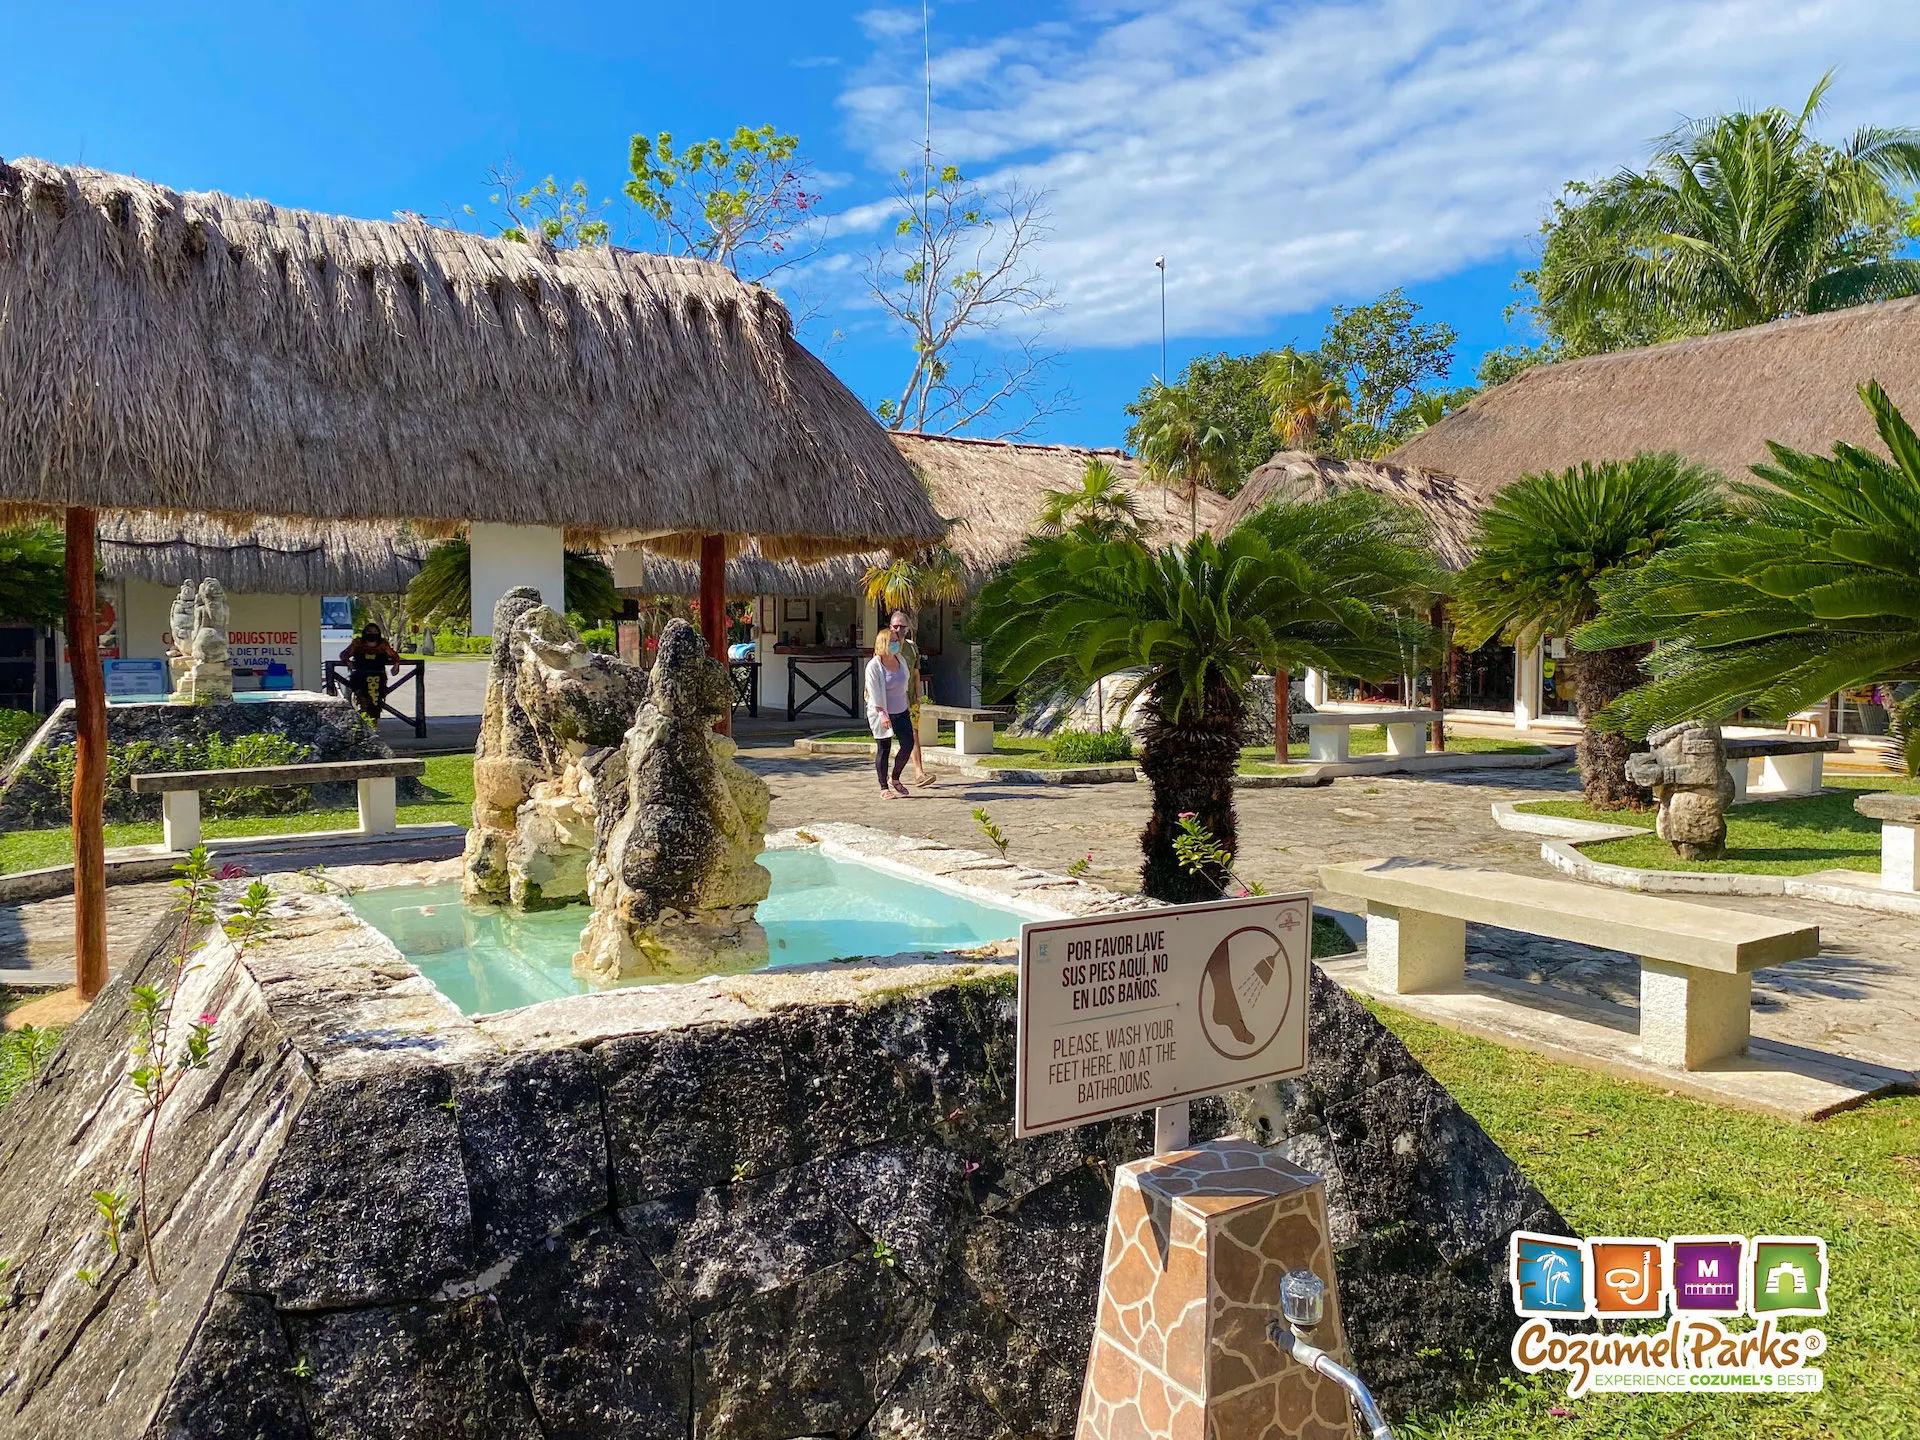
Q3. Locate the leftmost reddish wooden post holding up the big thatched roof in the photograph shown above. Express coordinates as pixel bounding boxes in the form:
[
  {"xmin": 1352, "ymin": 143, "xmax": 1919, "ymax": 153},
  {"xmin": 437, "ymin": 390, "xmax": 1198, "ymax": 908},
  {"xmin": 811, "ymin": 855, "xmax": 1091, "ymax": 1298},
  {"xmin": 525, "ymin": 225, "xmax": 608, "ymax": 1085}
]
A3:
[{"xmin": 67, "ymin": 507, "xmax": 108, "ymax": 1000}]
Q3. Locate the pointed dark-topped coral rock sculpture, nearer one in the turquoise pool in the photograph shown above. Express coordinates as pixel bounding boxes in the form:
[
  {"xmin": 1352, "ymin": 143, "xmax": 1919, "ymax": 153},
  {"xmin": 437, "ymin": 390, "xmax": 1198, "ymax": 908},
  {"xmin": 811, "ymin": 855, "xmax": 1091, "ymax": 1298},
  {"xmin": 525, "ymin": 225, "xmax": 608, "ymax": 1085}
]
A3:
[{"xmin": 574, "ymin": 620, "xmax": 772, "ymax": 983}]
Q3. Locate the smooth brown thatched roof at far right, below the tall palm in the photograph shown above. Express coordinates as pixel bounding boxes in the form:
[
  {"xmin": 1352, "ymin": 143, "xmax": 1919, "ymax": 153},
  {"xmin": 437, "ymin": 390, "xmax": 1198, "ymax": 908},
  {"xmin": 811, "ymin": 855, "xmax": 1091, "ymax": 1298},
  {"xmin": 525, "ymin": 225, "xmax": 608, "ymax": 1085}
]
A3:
[{"xmin": 1390, "ymin": 300, "xmax": 1920, "ymax": 499}]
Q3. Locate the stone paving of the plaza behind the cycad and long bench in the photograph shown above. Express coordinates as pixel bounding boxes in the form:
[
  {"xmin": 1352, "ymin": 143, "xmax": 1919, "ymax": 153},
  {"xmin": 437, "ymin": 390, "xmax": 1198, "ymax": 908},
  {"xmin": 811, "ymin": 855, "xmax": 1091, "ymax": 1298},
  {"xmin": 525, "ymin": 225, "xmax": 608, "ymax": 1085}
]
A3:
[{"xmin": 741, "ymin": 739, "xmax": 1920, "ymax": 1071}]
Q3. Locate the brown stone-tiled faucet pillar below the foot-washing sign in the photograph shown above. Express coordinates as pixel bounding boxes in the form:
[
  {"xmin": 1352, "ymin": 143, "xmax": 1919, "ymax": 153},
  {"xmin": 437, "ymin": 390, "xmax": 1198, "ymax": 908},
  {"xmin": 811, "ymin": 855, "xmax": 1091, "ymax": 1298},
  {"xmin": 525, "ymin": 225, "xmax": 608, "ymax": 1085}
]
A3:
[{"xmin": 1075, "ymin": 1140, "xmax": 1354, "ymax": 1440}]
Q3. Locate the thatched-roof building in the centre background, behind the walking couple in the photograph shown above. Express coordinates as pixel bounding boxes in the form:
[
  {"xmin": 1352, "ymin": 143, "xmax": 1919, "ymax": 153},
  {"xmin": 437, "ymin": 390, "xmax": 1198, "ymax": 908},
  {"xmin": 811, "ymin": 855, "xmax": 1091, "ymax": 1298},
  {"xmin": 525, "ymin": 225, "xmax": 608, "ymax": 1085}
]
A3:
[{"xmin": 612, "ymin": 432, "xmax": 1227, "ymax": 712}]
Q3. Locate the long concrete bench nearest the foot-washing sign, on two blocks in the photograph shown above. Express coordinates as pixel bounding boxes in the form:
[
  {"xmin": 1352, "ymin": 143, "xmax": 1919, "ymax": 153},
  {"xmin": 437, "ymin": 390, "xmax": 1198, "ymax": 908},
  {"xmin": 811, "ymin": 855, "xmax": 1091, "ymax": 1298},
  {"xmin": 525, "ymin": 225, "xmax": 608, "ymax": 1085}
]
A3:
[{"xmin": 1321, "ymin": 860, "xmax": 1820, "ymax": 1069}]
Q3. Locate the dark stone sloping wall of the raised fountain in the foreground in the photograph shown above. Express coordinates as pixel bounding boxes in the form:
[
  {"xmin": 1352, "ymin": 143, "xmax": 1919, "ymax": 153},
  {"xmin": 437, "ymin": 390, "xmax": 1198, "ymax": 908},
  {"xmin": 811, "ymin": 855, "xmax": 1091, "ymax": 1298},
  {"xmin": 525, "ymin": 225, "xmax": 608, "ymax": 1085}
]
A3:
[{"xmin": 0, "ymin": 881, "xmax": 1561, "ymax": 1440}]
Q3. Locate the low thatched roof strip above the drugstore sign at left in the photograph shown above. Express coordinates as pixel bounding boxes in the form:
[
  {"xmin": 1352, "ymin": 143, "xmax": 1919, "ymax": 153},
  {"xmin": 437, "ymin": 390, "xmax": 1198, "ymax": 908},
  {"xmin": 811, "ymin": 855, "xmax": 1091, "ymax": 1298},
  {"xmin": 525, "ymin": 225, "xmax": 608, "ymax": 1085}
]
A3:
[{"xmin": 98, "ymin": 511, "xmax": 430, "ymax": 595}]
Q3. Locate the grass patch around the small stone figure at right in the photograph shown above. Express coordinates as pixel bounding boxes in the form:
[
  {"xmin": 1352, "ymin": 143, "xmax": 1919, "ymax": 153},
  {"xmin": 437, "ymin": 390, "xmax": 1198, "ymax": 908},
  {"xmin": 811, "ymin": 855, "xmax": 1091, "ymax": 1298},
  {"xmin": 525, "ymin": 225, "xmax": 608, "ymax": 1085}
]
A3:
[{"xmin": 1515, "ymin": 776, "xmax": 1920, "ymax": 876}]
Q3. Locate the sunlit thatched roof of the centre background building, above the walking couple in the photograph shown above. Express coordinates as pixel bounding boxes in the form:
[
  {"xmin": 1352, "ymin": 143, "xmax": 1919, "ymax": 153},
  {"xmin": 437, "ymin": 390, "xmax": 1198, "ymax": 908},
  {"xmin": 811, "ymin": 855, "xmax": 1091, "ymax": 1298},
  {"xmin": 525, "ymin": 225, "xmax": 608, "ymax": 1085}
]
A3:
[{"xmin": 622, "ymin": 432, "xmax": 1227, "ymax": 595}]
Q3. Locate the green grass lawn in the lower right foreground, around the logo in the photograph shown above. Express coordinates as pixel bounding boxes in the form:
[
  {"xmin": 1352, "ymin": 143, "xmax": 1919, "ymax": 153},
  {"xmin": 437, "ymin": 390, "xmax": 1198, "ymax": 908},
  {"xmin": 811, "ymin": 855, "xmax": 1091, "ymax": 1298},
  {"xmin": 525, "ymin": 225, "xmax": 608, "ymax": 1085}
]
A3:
[{"xmin": 1375, "ymin": 1008, "xmax": 1920, "ymax": 1440}]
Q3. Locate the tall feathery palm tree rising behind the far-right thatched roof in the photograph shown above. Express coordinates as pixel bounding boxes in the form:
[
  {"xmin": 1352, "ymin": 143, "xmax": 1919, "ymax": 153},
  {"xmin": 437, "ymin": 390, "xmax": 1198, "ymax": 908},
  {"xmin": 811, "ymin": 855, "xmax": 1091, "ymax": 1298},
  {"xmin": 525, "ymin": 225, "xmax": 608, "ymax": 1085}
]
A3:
[{"xmin": 1540, "ymin": 75, "xmax": 1920, "ymax": 334}]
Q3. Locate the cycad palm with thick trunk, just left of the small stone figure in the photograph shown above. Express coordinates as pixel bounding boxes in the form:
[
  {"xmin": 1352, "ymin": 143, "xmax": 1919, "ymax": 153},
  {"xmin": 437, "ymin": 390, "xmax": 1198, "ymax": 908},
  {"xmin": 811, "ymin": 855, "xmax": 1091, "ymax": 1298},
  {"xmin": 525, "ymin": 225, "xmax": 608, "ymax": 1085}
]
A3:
[{"xmin": 1453, "ymin": 453, "xmax": 1720, "ymax": 810}]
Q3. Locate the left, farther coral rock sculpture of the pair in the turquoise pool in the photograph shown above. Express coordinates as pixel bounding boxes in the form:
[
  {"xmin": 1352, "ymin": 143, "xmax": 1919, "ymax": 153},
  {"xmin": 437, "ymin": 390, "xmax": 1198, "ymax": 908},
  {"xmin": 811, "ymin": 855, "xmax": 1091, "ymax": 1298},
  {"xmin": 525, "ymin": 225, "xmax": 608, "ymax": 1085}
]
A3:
[{"xmin": 463, "ymin": 586, "xmax": 647, "ymax": 910}]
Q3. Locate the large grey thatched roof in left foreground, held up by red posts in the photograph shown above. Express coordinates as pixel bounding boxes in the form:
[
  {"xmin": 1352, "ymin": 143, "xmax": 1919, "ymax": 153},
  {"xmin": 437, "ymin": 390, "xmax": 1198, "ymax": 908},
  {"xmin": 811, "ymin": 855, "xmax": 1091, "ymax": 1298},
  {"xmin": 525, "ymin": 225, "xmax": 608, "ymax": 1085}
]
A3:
[{"xmin": 0, "ymin": 159, "xmax": 941, "ymax": 559}]
